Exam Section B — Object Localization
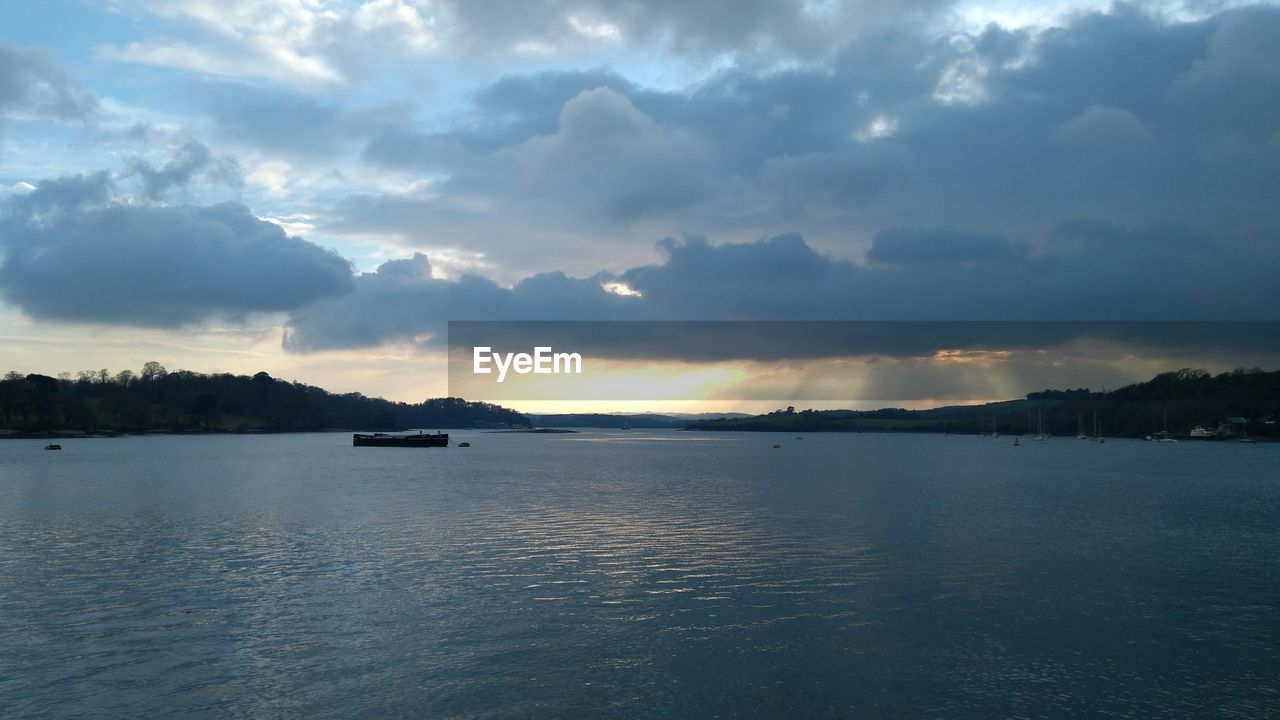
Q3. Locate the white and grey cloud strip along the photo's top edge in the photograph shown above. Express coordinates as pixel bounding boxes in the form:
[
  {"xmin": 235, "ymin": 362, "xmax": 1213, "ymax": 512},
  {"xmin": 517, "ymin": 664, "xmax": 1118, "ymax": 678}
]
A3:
[{"xmin": 106, "ymin": 0, "xmax": 954, "ymax": 78}]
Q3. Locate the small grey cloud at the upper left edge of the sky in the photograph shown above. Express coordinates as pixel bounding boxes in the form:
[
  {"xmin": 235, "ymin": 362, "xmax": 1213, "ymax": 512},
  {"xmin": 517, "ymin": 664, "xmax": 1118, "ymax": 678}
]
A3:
[{"xmin": 0, "ymin": 44, "xmax": 97, "ymax": 120}]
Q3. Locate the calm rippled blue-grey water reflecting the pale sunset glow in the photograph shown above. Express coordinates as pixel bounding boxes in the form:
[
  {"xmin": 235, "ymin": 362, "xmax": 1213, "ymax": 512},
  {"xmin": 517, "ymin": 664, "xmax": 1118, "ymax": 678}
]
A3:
[{"xmin": 0, "ymin": 430, "xmax": 1280, "ymax": 719}]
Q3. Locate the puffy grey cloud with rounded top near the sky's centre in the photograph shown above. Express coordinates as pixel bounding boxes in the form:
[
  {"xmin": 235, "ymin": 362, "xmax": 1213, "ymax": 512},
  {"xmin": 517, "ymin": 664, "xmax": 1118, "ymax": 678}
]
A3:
[{"xmin": 335, "ymin": 87, "xmax": 717, "ymax": 272}]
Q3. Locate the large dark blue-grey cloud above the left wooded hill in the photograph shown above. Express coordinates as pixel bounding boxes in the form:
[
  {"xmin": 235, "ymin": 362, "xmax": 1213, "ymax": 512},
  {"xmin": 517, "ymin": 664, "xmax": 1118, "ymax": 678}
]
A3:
[{"xmin": 0, "ymin": 173, "xmax": 351, "ymax": 327}]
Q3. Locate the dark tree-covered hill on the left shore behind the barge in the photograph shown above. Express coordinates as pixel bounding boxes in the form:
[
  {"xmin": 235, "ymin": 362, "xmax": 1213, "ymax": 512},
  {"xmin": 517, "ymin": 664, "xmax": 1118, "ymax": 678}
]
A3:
[{"xmin": 0, "ymin": 363, "xmax": 530, "ymax": 434}]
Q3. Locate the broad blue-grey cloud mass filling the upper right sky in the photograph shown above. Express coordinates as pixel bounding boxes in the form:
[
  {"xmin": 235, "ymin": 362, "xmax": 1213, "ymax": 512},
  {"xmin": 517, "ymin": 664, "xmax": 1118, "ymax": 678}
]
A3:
[{"xmin": 328, "ymin": 5, "xmax": 1280, "ymax": 278}]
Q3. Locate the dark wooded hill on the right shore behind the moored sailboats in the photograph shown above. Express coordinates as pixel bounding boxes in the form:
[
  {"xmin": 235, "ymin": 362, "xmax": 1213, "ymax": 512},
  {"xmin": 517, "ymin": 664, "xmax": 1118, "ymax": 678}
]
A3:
[{"xmin": 687, "ymin": 369, "xmax": 1280, "ymax": 438}]
